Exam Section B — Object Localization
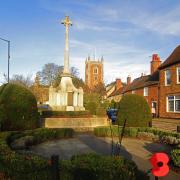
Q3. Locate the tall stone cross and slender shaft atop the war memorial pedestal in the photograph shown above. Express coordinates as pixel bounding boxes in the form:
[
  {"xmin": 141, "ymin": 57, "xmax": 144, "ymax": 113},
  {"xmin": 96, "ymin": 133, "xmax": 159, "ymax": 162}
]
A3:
[{"xmin": 61, "ymin": 16, "xmax": 72, "ymax": 74}]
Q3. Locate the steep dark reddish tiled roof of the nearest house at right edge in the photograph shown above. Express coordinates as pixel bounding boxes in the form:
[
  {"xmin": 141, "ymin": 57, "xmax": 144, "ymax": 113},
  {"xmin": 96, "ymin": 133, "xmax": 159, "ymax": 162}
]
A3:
[{"xmin": 159, "ymin": 45, "xmax": 180, "ymax": 69}]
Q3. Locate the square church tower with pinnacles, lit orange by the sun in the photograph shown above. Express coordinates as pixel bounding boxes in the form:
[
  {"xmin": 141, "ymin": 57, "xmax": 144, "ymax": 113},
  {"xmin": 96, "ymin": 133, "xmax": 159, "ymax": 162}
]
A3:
[{"xmin": 85, "ymin": 56, "xmax": 104, "ymax": 89}]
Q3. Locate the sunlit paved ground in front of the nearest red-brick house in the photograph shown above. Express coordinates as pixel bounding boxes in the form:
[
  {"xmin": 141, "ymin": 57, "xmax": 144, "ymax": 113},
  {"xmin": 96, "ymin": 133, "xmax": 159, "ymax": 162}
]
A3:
[{"xmin": 152, "ymin": 118, "xmax": 180, "ymax": 132}]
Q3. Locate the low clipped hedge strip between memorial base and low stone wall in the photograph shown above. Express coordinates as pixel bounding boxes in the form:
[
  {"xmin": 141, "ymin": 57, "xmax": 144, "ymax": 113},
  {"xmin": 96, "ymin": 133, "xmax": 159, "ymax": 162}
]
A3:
[{"xmin": 41, "ymin": 110, "xmax": 92, "ymax": 118}]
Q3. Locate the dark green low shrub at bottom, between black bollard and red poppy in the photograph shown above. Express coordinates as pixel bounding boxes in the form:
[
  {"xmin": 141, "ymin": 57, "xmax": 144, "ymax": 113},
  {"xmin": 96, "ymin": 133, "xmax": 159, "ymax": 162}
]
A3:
[{"xmin": 61, "ymin": 154, "xmax": 137, "ymax": 180}]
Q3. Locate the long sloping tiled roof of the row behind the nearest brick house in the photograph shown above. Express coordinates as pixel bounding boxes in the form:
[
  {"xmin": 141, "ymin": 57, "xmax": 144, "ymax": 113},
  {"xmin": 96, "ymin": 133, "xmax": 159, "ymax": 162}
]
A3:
[{"xmin": 123, "ymin": 71, "xmax": 159, "ymax": 92}]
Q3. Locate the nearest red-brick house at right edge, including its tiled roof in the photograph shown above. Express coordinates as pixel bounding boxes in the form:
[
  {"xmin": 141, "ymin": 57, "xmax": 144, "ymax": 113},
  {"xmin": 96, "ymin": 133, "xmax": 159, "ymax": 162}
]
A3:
[{"xmin": 159, "ymin": 46, "xmax": 180, "ymax": 118}]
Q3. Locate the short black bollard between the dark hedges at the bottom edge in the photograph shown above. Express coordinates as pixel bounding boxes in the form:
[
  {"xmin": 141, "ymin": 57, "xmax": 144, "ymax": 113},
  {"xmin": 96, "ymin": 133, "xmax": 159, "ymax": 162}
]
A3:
[{"xmin": 51, "ymin": 155, "xmax": 60, "ymax": 180}]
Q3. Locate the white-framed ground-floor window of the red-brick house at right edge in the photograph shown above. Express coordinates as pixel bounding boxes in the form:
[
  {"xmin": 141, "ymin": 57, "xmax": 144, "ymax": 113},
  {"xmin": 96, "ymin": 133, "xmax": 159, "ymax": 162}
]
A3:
[{"xmin": 167, "ymin": 95, "xmax": 180, "ymax": 112}]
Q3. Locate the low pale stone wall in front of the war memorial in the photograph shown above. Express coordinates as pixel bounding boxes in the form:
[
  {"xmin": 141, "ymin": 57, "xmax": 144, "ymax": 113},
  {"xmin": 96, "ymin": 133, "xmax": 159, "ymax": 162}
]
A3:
[{"xmin": 44, "ymin": 117, "xmax": 108, "ymax": 129}]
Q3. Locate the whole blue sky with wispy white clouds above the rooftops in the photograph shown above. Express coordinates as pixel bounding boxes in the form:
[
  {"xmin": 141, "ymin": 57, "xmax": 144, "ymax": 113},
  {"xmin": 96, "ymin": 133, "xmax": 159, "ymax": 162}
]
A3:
[{"xmin": 0, "ymin": 0, "xmax": 180, "ymax": 83}]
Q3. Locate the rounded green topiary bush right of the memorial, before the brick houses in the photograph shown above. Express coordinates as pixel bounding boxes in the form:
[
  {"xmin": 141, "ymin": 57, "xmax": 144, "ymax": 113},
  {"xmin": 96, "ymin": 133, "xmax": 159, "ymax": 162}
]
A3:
[{"xmin": 117, "ymin": 94, "xmax": 152, "ymax": 127}]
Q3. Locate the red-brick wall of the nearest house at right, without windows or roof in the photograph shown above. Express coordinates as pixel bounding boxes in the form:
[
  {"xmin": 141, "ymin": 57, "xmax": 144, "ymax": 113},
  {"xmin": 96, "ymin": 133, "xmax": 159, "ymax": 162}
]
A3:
[{"xmin": 160, "ymin": 63, "xmax": 180, "ymax": 118}]
